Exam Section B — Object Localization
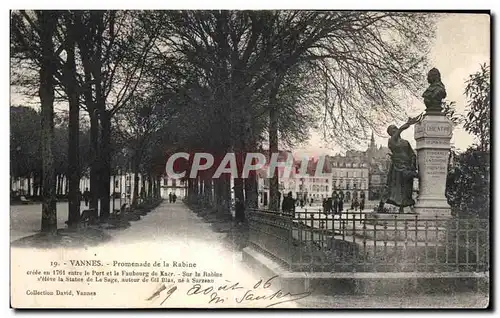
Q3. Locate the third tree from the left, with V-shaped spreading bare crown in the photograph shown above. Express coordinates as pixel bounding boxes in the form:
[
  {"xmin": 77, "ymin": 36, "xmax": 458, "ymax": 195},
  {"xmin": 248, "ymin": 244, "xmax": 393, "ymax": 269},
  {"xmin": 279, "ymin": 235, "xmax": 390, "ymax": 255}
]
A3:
[{"xmin": 72, "ymin": 11, "xmax": 161, "ymax": 221}]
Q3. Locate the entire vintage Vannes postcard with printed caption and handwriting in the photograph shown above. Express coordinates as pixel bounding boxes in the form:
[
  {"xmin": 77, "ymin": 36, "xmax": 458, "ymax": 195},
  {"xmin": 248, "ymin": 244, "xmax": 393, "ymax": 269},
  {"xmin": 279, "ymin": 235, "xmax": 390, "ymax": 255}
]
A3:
[{"xmin": 10, "ymin": 10, "xmax": 491, "ymax": 309}]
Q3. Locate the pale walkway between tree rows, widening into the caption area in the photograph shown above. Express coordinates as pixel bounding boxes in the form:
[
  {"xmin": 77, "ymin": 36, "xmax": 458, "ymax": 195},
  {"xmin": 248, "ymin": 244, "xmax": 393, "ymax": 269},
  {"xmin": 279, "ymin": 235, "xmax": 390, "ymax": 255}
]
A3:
[{"xmin": 12, "ymin": 202, "xmax": 300, "ymax": 308}]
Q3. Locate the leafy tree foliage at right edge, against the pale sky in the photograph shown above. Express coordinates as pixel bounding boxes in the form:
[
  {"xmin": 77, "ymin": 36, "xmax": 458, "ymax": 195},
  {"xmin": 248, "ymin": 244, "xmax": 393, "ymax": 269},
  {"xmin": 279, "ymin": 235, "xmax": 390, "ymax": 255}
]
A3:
[{"xmin": 464, "ymin": 63, "xmax": 491, "ymax": 151}]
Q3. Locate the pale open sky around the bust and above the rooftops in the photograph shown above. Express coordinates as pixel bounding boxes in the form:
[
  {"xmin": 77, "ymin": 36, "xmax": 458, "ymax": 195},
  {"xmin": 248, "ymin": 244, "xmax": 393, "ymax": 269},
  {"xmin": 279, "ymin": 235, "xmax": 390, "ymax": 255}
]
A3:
[{"xmin": 294, "ymin": 13, "xmax": 490, "ymax": 156}]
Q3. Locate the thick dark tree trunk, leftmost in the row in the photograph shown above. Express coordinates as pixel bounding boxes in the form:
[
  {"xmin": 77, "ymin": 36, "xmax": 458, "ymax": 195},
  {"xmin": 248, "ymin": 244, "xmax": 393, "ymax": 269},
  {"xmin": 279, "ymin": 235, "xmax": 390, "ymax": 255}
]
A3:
[{"xmin": 38, "ymin": 11, "xmax": 57, "ymax": 234}]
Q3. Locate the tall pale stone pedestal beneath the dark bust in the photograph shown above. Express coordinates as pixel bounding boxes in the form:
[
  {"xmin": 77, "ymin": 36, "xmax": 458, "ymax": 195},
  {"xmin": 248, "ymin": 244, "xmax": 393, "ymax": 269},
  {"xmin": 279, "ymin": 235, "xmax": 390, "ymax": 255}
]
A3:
[{"xmin": 415, "ymin": 113, "xmax": 453, "ymax": 218}]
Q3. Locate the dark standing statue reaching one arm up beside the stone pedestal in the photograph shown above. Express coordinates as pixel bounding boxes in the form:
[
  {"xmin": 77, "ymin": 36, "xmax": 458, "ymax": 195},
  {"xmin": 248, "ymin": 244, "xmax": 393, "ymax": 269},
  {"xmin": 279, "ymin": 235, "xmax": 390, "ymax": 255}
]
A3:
[{"xmin": 378, "ymin": 115, "xmax": 422, "ymax": 213}]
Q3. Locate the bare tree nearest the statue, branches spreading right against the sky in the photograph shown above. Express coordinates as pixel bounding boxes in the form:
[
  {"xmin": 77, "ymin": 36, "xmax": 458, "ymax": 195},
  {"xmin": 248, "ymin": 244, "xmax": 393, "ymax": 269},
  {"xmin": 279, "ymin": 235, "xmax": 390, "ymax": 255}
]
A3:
[{"xmin": 256, "ymin": 11, "xmax": 433, "ymax": 208}]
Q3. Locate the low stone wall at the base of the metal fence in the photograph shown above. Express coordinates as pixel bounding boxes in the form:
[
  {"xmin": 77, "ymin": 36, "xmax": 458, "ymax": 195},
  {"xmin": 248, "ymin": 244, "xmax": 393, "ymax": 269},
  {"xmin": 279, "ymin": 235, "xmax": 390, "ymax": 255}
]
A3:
[{"xmin": 243, "ymin": 246, "xmax": 489, "ymax": 295}]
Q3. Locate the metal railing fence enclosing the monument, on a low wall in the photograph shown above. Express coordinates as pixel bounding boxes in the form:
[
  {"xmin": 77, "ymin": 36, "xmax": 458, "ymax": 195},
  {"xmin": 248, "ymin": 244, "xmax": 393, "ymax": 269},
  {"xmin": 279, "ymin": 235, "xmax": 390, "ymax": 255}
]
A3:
[{"xmin": 249, "ymin": 209, "xmax": 489, "ymax": 272}]
